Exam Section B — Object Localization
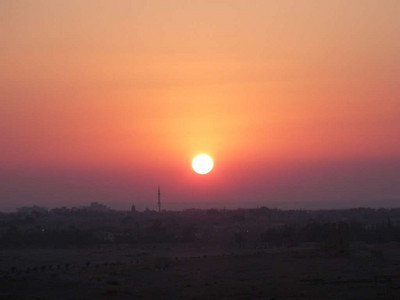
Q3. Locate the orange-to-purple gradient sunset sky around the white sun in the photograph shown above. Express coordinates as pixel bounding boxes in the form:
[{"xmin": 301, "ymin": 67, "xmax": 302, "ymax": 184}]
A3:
[{"xmin": 0, "ymin": 0, "xmax": 400, "ymax": 210}]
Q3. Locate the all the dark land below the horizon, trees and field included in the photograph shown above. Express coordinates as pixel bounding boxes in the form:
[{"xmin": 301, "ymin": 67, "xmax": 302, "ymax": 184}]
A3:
[{"xmin": 0, "ymin": 203, "xmax": 400, "ymax": 299}]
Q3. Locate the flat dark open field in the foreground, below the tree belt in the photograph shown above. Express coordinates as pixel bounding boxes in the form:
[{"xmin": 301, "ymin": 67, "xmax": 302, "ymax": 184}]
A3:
[{"xmin": 0, "ymin": 244, "xmax": 400, "ymax": 299}]
